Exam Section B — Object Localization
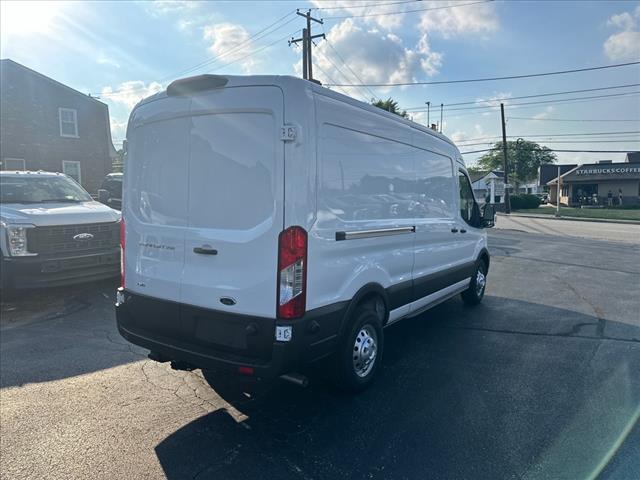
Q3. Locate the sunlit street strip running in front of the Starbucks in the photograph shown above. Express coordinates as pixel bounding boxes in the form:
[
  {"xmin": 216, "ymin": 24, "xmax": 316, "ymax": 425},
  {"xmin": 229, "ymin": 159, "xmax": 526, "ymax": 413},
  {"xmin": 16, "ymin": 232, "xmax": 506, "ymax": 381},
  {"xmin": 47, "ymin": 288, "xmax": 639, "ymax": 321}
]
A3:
[{"xmin": 496, "ymin": 215, "xmax": 640, "ymax": 244}]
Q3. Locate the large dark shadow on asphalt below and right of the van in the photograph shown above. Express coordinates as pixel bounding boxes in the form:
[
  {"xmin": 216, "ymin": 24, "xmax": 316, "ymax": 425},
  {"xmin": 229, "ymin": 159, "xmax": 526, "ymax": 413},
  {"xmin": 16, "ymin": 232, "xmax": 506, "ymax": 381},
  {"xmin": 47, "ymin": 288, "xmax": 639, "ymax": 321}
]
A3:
[{"xmin": 156, "ymin": 297, "xmax": 640, "ymax": 479}]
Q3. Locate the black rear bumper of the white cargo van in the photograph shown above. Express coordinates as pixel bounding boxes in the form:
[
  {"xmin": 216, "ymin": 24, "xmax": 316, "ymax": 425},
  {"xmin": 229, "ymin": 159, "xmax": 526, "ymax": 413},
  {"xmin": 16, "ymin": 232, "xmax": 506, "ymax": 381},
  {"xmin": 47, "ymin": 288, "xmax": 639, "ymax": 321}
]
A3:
[{"xmin": 116, "ymin": 290, "xmax": 348, "ymax": 379}]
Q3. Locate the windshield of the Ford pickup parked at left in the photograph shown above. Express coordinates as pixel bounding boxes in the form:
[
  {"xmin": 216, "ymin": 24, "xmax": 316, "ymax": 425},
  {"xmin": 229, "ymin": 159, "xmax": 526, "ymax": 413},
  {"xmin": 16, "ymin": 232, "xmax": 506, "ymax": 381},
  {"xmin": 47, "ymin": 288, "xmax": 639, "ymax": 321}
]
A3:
[{"xmin": 0, "ymin": 175, "xmax": 91, "ymax": 203}]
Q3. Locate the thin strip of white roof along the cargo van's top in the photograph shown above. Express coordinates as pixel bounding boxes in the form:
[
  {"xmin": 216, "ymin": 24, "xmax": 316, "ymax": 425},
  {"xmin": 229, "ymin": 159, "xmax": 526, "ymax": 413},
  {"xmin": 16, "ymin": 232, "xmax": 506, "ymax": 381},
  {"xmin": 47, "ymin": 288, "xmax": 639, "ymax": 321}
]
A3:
[{"xmin": 136, "ymin": 75, "xmax": 456, "ymax": 148}]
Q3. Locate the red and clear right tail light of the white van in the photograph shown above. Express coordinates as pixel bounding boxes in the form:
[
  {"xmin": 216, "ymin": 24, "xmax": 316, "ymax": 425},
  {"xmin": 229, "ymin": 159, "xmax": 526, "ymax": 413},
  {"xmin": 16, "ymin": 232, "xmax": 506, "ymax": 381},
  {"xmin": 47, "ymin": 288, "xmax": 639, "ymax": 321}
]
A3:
[{"xmin": 277, "ymin": 227, "xmax": 307, "ymax": 318}]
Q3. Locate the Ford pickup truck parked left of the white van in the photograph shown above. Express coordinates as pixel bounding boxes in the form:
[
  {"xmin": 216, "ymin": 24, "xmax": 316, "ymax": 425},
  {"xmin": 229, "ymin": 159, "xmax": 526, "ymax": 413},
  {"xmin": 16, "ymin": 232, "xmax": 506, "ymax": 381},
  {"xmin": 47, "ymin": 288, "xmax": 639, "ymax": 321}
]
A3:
[{"xmin": 0, "ymin": 171, "xmax": 120, "ymax": 289}]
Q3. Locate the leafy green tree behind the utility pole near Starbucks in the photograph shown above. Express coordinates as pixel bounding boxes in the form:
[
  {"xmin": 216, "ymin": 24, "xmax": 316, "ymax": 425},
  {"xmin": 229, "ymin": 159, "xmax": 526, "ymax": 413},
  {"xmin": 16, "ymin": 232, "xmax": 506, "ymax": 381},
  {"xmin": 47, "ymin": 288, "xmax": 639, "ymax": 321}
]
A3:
[{"xmin": 476, "ymin": 139, "xmax": 557, "ymax": 185}]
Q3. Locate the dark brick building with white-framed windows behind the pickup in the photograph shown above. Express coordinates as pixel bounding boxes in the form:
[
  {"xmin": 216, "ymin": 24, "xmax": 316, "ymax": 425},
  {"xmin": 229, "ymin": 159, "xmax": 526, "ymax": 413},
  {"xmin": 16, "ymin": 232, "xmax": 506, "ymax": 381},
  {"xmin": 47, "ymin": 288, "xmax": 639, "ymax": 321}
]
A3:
[{"xmin": 0, "ymin": 59, "xmax": 117, "ymax": 194}]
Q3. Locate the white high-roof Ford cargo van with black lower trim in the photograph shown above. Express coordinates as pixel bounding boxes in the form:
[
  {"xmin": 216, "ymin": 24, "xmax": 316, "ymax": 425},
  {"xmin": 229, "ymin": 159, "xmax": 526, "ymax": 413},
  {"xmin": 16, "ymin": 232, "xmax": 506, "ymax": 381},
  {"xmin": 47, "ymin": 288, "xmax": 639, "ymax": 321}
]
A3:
[{"xmin": 116, "ymin": 75, "xmax": 494, "ymax": 390}]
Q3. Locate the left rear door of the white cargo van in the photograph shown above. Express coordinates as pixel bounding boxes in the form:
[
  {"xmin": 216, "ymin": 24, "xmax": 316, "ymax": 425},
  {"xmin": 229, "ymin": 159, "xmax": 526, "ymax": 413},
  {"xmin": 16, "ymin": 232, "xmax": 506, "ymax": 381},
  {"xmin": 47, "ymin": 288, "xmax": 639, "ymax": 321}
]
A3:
[{"xmin": 122, "ymin": 98, "xmax": 191, "ymax": 302}]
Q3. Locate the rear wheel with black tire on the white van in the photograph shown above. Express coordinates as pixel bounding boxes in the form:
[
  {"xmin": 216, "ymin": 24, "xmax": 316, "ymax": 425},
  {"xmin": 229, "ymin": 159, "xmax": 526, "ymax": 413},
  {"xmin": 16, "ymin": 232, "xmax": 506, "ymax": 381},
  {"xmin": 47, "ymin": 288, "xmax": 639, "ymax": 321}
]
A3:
[{"xmin": 336, "ymin": 305, "xmax": 384, "ymax": 392}]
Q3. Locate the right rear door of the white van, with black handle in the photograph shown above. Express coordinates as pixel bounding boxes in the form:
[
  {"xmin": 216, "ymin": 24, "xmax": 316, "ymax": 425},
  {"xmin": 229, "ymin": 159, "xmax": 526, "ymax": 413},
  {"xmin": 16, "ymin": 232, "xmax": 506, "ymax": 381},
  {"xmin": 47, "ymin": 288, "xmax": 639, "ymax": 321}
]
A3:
[{"xmin": 181, "ymin": 86, "xmax": 284, "ymax": 317}]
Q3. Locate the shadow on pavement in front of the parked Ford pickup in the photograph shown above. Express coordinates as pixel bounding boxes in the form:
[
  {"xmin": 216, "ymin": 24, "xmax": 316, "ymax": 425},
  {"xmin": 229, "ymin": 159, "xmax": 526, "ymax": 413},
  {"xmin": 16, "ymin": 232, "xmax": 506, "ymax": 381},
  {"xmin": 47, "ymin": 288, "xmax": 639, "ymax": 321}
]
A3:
[{"xmin": 0, "ymin": 280, "xmax": 146, "ymax": 388}]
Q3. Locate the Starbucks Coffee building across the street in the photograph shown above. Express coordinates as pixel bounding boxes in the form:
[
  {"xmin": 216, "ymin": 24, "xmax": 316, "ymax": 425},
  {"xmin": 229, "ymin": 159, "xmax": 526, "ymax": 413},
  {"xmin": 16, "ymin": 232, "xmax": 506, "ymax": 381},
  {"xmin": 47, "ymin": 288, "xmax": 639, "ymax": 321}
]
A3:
[{"xmin": 541, "ymin": 152, "xmax": 640, "ymax": 206}]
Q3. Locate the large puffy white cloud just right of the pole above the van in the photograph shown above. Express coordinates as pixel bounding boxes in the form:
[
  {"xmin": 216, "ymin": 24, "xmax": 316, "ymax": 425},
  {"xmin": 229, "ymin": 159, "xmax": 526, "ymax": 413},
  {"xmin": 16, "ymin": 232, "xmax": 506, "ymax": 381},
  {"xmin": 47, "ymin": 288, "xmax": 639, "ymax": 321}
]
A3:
[{"xmin": 308, "ymin": 19, "xmax": 442, "ymax": 96}]
